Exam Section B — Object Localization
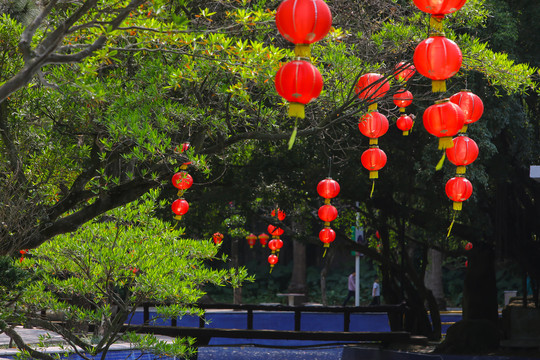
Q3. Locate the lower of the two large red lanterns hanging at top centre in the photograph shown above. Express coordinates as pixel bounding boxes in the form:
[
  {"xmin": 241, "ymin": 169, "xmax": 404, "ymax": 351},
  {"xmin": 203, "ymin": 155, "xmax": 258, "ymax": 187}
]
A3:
[{"xmin": 275, "ymin": 60, "xmax": 323, "ymax": 119}]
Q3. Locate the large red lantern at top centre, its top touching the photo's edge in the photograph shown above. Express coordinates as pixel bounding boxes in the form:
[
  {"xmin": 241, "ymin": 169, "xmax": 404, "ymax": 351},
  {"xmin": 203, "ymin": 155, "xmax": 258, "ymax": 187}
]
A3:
[{"xmin": 276, "ymin": 0, "xmax": 332, "ymax": 57}]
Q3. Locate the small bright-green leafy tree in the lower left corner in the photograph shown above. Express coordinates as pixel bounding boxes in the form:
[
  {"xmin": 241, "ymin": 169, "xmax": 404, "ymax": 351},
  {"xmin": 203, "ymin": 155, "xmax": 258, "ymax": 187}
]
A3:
[{"xmin": 0, "ymin": 190, "xmax": 247, "ymax": 359}]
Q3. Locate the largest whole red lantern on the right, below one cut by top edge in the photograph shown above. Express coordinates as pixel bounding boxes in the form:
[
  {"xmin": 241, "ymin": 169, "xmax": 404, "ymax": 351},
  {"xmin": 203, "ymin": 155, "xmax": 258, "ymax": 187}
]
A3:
[{"xmin": 413, "ymin": 35, "xmax": 462, "ymax": 92}]
